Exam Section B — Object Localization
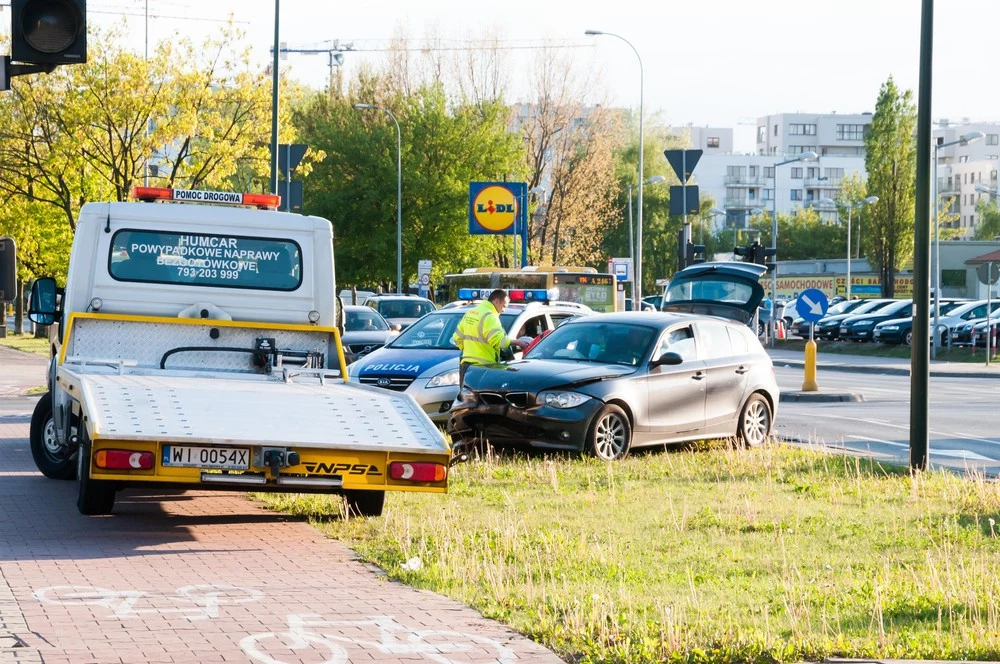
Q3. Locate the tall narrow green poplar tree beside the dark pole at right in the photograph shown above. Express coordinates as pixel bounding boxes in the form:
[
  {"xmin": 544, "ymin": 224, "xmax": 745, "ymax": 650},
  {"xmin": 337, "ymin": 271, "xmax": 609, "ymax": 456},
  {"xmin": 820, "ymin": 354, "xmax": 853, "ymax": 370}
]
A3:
[{"xmin": 862, "ymin": 76, "xmax": 917, "ymax": 297}]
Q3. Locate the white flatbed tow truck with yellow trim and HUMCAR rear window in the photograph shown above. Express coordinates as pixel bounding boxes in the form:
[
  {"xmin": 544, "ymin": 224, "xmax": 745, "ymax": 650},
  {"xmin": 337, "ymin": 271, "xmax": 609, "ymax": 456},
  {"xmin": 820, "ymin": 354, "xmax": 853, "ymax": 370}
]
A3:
[{"xmin": 29, "ymin": 187, "xmax": 451, "ymax": 516}]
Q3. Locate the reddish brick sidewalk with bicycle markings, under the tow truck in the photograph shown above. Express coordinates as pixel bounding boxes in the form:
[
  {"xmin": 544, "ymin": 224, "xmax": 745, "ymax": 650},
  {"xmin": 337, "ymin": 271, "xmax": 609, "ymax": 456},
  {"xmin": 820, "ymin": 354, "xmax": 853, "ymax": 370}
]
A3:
[{"xmin": 0, "ymin": 417, "xmax": 561, "ymax": 664}]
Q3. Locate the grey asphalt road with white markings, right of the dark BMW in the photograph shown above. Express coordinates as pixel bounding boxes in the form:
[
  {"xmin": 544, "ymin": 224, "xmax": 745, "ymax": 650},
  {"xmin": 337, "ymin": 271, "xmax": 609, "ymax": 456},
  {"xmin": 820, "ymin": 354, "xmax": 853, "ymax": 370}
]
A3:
[{"xmin": 775, "ymin": 364, "xmax": 1000, "ymax": 476}]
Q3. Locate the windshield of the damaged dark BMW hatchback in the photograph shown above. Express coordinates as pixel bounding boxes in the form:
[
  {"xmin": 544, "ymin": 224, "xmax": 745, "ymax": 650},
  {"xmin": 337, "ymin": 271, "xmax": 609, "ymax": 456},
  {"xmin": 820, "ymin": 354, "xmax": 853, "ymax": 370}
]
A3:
[{"xmin": 531, "ymin": 323, "xmax": 656, "ymax": 366}]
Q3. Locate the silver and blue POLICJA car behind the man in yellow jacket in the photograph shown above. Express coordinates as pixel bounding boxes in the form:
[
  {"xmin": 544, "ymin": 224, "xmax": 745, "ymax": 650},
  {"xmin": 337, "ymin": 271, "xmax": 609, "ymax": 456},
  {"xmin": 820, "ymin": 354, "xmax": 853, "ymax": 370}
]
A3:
[{"xmin": 348, "ymin": 288, "xmax": 593, "ymax": 424}]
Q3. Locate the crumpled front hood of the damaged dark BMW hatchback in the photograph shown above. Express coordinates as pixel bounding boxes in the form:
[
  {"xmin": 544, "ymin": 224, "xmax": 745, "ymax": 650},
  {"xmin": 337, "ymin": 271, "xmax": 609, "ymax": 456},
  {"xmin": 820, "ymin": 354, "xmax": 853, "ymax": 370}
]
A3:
[{"xmin": 465, "ymin": 360, "xmax": 636, "ymax": 392}]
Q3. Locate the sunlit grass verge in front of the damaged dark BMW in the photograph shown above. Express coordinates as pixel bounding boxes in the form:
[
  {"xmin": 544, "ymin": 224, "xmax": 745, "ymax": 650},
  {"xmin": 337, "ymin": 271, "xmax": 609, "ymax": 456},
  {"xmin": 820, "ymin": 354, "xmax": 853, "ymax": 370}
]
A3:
[{"xmin": 259, "ymin": 445, "xmax": 1000, "ymax": 663}]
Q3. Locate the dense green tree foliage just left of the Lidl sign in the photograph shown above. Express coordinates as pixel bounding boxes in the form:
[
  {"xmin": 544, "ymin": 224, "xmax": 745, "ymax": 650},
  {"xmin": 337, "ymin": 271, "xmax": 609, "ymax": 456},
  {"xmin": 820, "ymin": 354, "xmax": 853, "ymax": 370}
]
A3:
[{"xmin": 293, "ymin": 78, "xmax": 524, "ymax": 285}]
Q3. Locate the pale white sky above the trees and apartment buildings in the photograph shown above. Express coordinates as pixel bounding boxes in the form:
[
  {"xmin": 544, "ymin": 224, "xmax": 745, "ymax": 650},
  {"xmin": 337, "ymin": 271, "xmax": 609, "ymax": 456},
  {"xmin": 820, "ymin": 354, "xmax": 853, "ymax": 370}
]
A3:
[{"xmin": 78, "ymin": 0, "xmax": 1000, "ymax": 152}]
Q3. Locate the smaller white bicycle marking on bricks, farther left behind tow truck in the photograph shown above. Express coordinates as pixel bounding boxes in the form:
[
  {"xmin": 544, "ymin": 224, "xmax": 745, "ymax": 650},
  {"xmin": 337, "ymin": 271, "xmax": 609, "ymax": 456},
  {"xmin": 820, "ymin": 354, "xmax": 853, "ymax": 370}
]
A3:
[{"xmin": 34, "ymin": 584, "xmax": 264, "ymax": 621}]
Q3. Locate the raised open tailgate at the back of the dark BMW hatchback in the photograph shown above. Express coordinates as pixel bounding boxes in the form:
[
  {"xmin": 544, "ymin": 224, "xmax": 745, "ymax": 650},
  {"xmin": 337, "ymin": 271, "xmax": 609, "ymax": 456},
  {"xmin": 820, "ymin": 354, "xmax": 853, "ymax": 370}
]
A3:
[{"xmin": 660, "ymin": 262, "xmax": 767, "ymax": 323}]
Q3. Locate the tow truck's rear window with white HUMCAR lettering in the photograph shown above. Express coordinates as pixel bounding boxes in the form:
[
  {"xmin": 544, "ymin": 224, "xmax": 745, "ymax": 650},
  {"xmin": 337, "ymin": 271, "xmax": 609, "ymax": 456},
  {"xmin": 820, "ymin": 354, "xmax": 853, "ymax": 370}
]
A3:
[{"xmin": 108, "ymin": 230, "xmax": 302, "ymax": 291}]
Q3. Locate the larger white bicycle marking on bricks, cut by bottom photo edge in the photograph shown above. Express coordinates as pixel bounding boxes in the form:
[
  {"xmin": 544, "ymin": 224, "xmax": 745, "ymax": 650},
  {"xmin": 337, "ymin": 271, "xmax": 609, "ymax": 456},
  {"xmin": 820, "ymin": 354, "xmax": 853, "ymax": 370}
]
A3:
[{"xmin": 240, "ymin": 613, "xmax": 517, "ymax": 664}]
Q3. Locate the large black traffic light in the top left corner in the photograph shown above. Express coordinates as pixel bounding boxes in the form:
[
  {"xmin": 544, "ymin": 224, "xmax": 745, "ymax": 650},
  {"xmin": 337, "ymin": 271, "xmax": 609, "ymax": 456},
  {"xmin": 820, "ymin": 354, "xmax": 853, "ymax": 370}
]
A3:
[{"xmin": 10, "ymin": 0, "xmax": 87, "ymax": 66}]
